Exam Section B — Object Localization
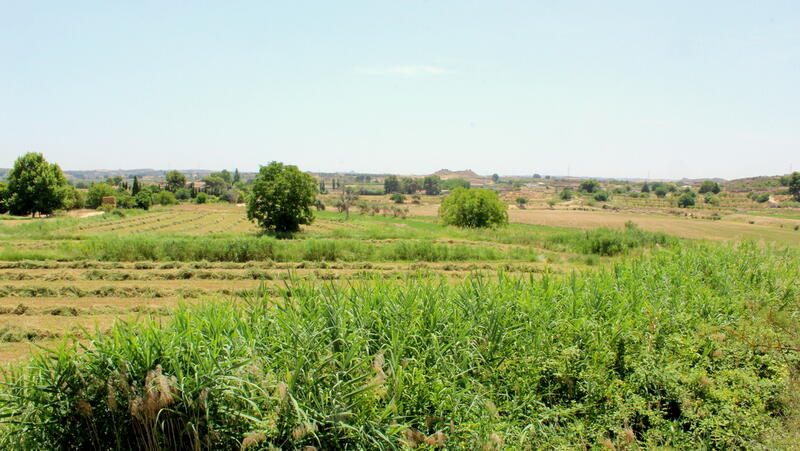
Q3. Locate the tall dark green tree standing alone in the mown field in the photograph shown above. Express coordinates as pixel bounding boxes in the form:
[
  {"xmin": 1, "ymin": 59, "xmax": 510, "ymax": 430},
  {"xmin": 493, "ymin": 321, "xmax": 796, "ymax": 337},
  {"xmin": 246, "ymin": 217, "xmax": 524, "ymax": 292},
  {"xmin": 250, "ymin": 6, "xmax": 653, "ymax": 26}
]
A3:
[{"xmin": 247, "ymin": 161, "xmax": 317, "ymax": 233}]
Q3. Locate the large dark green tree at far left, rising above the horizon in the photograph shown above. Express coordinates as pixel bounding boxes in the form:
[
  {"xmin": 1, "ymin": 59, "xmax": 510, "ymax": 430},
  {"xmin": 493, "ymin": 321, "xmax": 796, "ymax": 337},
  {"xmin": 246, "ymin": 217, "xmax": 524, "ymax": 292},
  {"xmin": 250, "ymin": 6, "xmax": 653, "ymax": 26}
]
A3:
[{"xmin": 6, "ymin": 152, "xmax": 67, "ymax": 216}]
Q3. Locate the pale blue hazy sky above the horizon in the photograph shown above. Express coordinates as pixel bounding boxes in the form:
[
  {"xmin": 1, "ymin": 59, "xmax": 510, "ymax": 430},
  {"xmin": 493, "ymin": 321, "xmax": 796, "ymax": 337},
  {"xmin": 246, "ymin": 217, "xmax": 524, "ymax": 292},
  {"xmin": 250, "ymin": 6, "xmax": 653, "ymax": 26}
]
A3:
[{"xmin": 0, "ymin": 0, "xmax": 800, "ymax": 178}]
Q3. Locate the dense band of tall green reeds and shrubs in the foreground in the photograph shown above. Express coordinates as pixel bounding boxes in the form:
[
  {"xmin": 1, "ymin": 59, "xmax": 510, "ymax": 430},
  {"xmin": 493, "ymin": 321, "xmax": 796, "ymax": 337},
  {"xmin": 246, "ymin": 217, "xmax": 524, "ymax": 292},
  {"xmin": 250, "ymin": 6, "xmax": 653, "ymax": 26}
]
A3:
[{"xmin": 0, "ymin": 246, "xmax": 800, "ymax": 449}]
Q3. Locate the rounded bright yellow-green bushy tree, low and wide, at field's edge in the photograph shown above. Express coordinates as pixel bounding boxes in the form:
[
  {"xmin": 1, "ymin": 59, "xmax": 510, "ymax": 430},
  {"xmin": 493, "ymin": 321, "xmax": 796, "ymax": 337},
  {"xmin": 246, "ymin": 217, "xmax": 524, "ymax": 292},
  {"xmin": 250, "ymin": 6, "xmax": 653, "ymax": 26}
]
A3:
[{"xmin": 439, "ymin": 188, "xmax": 508, "ymax": 228}]
